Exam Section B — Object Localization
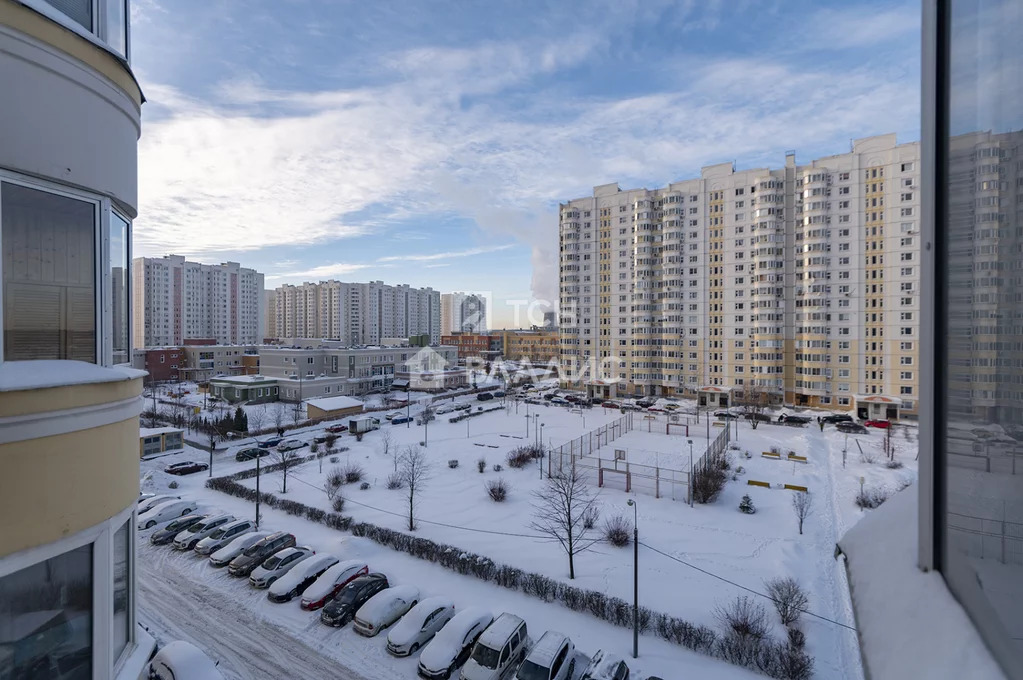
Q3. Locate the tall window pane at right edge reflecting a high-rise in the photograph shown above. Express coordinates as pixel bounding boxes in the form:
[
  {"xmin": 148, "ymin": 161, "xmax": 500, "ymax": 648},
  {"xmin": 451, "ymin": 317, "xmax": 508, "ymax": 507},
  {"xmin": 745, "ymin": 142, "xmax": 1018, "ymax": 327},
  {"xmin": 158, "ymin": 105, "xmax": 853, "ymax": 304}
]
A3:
[{"xmin": 935, "ymin": 0, "xmax": 1023, "ymax": 668}]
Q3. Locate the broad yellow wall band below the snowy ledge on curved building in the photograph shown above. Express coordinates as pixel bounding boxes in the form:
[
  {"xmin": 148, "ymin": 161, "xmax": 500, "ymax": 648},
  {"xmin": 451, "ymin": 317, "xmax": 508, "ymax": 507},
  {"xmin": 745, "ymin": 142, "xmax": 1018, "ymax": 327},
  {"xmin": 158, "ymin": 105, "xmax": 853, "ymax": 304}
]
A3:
[{"xmin": 0, "ymin": 417, "xmax": 138, "ymax": 557}]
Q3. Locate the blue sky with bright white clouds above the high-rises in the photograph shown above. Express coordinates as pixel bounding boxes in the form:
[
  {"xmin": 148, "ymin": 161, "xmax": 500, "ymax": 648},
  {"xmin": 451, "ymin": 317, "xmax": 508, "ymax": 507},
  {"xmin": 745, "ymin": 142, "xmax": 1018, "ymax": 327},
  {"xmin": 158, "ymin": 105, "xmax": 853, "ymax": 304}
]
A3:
[{"xmin": 132, "ymin": 0, "xmax": 920, "ymax": 327}]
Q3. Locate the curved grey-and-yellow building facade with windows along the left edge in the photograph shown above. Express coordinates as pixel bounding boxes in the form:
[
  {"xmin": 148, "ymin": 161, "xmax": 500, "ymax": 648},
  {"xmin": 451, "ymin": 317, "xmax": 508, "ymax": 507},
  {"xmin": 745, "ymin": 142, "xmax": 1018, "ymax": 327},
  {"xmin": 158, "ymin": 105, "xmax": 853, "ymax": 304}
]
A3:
[{"xmin": 0, "ymin": 0, "xmax": 153, "ymax": 680}]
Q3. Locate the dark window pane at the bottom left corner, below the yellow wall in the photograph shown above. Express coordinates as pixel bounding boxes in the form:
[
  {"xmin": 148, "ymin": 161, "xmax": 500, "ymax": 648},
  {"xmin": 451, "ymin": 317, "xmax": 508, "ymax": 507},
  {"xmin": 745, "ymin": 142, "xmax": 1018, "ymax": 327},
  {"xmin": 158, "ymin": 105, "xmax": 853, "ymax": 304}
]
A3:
[{"xmin": 0, "ymin": 545, "xmax": 92, "ymax": 680}]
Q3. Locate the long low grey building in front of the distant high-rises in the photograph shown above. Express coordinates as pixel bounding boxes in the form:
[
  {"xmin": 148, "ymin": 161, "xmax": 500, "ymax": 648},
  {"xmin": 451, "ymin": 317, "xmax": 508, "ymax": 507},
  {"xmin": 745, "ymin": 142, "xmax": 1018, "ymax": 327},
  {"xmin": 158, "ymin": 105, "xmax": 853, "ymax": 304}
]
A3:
[{"xmin": 259, "ymin": 345, "xmax": 458, "ymax": 401}]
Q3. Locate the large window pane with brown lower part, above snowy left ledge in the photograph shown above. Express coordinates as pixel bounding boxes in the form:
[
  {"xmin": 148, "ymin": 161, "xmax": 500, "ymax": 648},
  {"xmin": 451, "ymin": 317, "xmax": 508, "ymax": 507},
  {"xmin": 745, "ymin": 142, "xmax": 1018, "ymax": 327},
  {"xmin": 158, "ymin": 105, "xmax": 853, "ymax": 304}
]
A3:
[{"xmin": 0, "ymin": 183, "xmax": 96, "ymax": 362}]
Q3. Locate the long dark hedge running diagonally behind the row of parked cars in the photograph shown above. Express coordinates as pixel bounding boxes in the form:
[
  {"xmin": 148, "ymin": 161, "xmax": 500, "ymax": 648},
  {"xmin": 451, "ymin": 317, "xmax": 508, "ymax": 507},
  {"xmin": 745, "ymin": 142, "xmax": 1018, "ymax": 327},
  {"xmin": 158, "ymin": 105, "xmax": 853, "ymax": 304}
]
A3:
[{"xmin": 206, "ymin": 470, "xmax": 813, "ymax": 680}]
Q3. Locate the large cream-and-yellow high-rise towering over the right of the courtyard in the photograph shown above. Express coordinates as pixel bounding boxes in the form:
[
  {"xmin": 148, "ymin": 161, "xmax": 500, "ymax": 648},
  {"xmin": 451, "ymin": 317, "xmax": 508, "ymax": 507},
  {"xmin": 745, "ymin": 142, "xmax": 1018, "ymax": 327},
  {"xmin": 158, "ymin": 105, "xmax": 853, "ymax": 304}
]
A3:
[{"xmin": 560, "ymin": 135, "xmax": 921, "ymax": 416}]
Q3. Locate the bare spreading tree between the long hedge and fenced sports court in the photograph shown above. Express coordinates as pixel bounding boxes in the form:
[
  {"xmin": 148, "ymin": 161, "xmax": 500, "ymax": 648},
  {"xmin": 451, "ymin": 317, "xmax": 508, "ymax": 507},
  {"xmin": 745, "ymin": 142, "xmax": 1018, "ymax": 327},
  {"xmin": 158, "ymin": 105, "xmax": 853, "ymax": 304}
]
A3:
[{"xmin": 529, "ymin": 465, "xmax": 601, "ymax": 579}]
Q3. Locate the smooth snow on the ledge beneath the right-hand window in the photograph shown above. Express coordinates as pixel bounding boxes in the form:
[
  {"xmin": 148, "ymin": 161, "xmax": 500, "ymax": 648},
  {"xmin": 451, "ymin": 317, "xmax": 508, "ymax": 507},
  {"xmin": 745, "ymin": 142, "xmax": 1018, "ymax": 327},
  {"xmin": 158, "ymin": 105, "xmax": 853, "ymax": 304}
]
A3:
[{"xmin": 838, "ymin": 485, "xmax": 1006, "ymax": 680}]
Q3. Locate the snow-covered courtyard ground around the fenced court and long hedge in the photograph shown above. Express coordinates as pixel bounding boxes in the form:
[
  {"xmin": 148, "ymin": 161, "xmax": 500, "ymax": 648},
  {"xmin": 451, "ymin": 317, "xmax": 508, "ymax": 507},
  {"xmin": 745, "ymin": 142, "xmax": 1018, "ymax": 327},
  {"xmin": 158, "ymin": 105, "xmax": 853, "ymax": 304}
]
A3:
[{"xmin": 139, "ymin": 400, "xmax": 916, "ymax": 678}]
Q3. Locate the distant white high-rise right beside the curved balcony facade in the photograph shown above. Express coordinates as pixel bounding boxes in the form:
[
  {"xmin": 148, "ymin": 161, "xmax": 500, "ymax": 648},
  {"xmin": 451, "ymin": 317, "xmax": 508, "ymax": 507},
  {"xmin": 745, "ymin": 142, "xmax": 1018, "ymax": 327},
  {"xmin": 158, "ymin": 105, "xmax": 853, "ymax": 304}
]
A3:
[{"xmin": 132, "ymin": 255, "xmax": 266, "ymax": 347}]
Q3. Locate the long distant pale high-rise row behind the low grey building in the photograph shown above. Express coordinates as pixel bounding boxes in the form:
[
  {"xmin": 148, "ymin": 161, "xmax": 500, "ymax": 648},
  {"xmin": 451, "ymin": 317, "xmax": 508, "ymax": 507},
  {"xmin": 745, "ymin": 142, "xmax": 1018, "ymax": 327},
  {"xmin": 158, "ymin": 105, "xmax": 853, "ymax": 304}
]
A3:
[{"xmin": 274, "ymin": 281, "xmax": 441, "ymax": 346}]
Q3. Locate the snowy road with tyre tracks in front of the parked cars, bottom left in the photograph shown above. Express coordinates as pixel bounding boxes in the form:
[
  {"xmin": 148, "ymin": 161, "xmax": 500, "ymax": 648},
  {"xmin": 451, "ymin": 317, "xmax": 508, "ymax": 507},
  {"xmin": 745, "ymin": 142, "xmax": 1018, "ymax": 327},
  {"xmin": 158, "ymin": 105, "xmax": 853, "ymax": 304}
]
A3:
[{"xmin": 138, "ymin": 545, "xmax": 367, "ymax": 680}]
